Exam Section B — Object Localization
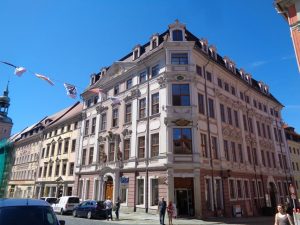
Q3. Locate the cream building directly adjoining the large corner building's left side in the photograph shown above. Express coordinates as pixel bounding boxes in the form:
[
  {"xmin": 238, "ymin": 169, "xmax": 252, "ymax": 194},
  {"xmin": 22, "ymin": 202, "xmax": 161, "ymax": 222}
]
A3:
[{"xmin": 35, "ymin": 102, "xmax": 82, "ymax": 197}]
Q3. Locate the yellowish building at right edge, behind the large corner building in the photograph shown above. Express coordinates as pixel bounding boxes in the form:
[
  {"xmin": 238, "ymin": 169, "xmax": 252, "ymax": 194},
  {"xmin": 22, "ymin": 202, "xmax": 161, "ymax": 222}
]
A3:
[{"xmin": 284, "ymin": 127, "xmax": 300, "ymax": 201}]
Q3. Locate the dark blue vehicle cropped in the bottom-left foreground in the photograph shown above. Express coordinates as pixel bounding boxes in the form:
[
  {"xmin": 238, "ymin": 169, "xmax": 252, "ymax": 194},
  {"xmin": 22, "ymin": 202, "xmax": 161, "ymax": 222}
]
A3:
[{"xmin": 0, "ymin": 198, "xmax": 65, "ymax": 225}]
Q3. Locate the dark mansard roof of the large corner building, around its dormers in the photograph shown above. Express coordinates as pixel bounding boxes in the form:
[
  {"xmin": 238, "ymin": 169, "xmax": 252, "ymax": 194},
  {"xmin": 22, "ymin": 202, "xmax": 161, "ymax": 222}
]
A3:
[{"xmin": 84, "ymin": 21, "xmax": 283, "ymax": 106}]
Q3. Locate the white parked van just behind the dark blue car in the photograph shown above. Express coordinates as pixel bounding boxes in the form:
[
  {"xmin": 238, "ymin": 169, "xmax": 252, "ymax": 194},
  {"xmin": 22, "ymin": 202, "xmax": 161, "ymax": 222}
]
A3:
[{"xmin": 52, "ymin": 196, "xmax": 80, "ymax": 215}]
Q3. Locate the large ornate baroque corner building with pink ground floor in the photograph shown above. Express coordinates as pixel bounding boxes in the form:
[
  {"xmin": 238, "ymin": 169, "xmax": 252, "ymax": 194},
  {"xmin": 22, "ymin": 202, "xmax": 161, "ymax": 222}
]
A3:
[{"xmin": 74, "ymin": 21, "xmax": 291, "ymax": 217}]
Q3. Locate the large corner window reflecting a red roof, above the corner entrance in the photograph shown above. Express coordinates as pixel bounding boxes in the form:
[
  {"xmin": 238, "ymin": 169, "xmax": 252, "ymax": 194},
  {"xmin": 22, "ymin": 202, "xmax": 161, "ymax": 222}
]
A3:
[{"xmin": 173, "ymin": 128, "xmax": 192, "ymax": 154}]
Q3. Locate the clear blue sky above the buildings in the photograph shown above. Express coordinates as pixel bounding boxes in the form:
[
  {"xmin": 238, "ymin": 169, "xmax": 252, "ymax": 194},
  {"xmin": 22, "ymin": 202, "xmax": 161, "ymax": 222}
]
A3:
[{"xmin": 0, "ymin": 0, "xmax": 300, "ymax": 133}]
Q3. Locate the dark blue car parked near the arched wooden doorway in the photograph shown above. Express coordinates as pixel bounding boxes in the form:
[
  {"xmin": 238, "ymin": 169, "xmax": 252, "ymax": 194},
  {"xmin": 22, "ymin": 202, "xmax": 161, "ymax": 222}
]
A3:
[{"xmin": 73, "ymin": 200, "xmax": 107, "ymax": 219}]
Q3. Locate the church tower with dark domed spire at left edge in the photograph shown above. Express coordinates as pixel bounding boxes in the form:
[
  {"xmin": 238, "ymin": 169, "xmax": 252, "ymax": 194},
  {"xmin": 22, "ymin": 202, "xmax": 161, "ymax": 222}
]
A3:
[{"xmin": 0, "ymin": 84, "xmax": 13, "ymax": 141}]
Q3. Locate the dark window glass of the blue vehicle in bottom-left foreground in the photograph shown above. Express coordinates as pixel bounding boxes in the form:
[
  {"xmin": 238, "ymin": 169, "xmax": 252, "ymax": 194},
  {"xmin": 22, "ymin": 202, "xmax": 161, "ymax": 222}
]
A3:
[{"xmin": 0, "ymin": 206, "xmax": 58, "ymax": 225}]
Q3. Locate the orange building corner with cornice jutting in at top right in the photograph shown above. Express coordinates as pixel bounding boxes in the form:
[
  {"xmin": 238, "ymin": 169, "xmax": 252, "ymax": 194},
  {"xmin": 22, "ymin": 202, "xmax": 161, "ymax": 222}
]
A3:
[{"xmin": 274, "ymin": 0, "xmax": 300, "ymax": 70}]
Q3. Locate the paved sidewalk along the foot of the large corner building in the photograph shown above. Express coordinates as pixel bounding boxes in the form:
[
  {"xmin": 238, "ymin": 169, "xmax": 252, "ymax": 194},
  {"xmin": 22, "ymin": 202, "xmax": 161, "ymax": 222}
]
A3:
[{"xmin": 115, "ymin": 212, "xmax": 274, "ymax": 225}]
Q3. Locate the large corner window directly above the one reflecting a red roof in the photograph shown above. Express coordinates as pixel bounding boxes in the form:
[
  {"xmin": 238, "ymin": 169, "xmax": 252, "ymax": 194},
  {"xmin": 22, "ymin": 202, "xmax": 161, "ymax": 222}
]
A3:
[{"xmin": 172, "ymin": 84, "xmax": 190, "ymax": 106}]
